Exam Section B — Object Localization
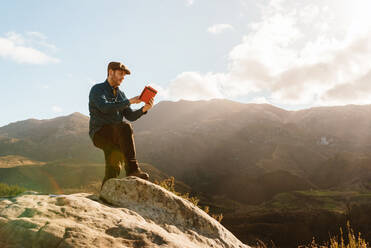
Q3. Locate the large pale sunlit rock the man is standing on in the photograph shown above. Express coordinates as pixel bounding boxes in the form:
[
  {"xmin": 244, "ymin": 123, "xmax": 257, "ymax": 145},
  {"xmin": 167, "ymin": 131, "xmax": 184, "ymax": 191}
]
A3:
[{"xmin": 0, "ymin": 177, "xmax": 248, "ymax": 248}]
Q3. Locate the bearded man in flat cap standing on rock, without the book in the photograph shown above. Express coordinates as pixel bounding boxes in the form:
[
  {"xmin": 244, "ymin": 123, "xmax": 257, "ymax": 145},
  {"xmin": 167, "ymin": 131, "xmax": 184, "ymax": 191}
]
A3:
[{"xmin": 89, "ymin": 62, "xmax": 153, "ymax": 189}]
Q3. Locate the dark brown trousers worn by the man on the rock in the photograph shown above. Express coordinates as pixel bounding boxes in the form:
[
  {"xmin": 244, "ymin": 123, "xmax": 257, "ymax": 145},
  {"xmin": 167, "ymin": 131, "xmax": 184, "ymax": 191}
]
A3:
[{"xmin": 93, "ymin": 121, "xmax": 138, "ymax": 189}]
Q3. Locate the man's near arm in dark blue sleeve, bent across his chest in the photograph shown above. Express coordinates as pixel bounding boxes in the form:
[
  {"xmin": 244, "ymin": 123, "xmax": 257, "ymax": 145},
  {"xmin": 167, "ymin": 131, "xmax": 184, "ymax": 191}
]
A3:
[{"xmin": 89, "ymin": 87, "xmax": 130, "ymax": 114}]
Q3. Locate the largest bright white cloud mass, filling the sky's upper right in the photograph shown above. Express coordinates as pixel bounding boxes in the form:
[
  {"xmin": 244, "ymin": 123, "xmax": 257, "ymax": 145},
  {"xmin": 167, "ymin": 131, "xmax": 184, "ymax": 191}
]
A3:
[{"xmin": 166, "ymin": 0, "xmax": 371, "ymax": 106}]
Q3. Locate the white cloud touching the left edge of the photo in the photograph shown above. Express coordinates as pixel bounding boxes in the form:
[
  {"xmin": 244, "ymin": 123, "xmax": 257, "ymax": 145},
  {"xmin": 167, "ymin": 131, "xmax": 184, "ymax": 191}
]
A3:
[{"xmin": 0, "ymin": 32, "xmax": 59, "ymax": 64}]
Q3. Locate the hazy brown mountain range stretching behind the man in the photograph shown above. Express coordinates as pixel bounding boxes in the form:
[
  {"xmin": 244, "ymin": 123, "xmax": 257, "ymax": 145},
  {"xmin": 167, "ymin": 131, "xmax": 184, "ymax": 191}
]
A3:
[{"xmin": 0, "ymin": 99, "xmax": 371, "ymax": 204}]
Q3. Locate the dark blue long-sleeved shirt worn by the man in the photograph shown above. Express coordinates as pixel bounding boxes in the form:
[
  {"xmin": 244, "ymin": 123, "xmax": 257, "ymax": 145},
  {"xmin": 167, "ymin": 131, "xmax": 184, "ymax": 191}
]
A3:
[{"xmin": 89, "ymin": 79, "xmax": 147, "ymax": 140}]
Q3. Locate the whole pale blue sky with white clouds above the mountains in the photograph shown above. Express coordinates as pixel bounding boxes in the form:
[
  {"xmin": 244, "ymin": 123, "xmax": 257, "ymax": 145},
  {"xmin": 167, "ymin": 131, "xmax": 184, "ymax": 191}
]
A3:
[{"xmin": 0, "ymin": 0, "xmax": 371, "ymax": 126}]
